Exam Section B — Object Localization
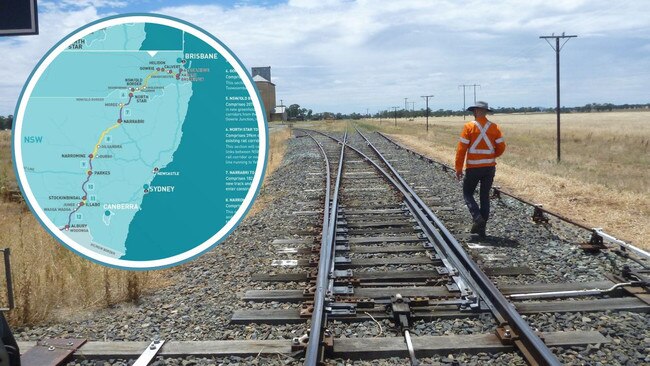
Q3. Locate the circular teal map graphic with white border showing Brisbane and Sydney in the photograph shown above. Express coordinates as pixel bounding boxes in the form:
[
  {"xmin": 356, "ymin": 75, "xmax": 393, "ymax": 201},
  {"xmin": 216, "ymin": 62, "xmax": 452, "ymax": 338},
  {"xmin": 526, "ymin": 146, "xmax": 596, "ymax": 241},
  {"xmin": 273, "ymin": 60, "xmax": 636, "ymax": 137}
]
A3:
[{"xmin": 13, "ymin": 15, "xmax": 267, "ymax": 269}]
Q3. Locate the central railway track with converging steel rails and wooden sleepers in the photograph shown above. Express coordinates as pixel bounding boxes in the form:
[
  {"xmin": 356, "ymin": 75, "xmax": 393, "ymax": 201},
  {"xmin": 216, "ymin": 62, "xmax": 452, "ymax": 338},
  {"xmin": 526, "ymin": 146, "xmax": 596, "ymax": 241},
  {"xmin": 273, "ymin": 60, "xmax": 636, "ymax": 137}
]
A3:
[{"xmin": 233, "ymin": 125, "xmax": 647, "ymax": 365}]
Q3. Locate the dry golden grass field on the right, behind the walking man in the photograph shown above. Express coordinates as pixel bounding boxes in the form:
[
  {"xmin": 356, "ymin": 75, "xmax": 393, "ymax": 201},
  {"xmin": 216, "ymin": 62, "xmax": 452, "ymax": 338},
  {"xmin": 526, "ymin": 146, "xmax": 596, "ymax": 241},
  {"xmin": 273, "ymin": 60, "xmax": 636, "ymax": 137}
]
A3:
[{"xmin": 342, "ymin": 111, "xmax": 650, "ymax": 249}]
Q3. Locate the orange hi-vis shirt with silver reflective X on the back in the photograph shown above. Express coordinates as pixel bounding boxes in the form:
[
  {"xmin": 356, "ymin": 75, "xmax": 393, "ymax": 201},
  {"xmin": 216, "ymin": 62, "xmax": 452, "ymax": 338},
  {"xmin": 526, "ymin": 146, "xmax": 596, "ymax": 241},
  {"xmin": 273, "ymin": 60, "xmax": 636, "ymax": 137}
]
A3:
[{"xmin": 456, "ymin": 117, "xmax": 506, "ymax": 172}]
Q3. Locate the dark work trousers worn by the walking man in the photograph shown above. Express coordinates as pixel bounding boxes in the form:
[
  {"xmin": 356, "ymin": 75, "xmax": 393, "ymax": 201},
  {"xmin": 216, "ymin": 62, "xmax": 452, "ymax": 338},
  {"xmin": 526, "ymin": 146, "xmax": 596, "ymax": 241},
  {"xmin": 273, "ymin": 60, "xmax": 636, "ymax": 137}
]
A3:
[{"xmin": 463, "ymin": 166, "xmax": 496, "ymax": 221}]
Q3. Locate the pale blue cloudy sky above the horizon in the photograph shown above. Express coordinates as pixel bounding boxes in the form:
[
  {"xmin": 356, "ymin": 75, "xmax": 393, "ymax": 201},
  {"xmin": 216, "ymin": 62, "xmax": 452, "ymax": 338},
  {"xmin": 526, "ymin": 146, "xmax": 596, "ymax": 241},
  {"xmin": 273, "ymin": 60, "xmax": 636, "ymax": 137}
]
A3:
[{"xmin": 0, "ymin": 0, "xmax": 650, "ymax": 115}]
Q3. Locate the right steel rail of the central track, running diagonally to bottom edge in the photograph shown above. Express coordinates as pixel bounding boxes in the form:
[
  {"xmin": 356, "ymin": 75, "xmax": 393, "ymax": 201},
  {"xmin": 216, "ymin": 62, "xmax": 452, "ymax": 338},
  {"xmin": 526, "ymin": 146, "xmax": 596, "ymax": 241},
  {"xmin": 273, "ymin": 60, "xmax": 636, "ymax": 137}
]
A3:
[{"xmin": 357, "ymin": 130, "xmax": 560, "ymax": 365}]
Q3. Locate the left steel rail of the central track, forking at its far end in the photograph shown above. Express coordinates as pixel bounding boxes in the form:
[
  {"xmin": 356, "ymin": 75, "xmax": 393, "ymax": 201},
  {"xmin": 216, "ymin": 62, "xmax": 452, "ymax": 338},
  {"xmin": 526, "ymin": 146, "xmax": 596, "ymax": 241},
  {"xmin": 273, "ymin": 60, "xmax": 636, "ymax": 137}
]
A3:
[{"xmin": 305, "ymin": 133, "xmax": 347, "ymax": 366}]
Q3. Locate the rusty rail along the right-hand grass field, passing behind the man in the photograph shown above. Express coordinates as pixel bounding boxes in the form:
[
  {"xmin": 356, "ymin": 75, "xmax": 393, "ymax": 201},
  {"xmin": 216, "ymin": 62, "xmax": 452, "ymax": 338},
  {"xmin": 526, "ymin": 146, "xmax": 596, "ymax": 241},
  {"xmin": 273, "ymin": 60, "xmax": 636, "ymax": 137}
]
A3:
[{"xmin": 377, "ymin": 131, "xmax": 650, "ymax": 260}]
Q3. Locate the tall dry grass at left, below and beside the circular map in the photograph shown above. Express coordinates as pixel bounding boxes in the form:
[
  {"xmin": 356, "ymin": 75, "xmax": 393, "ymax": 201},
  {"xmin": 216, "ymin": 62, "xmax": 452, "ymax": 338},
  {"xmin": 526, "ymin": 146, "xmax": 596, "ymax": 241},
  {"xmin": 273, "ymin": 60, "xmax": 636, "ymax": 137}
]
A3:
[{"xmin": 0, "ymin": 128, "xmax": 290, "ymax": 326}]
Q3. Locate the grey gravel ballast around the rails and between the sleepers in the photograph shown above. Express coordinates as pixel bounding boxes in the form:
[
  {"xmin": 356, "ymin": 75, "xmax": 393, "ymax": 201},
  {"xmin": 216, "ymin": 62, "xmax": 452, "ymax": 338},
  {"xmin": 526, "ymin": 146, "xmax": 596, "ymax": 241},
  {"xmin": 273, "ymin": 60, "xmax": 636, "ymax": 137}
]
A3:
[{"xmin": 14, "ymin": 128, "xmax": 650, "ymax": 366}]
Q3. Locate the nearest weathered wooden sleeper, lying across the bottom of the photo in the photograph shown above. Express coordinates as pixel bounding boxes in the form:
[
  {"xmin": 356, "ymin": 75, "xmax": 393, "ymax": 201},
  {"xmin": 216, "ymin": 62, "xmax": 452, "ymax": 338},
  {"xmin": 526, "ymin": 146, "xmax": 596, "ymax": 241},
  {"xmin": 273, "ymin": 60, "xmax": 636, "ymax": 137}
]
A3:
[{"xmin": 18, "ymin": 329, "xmax": 611, "ymax": 365}]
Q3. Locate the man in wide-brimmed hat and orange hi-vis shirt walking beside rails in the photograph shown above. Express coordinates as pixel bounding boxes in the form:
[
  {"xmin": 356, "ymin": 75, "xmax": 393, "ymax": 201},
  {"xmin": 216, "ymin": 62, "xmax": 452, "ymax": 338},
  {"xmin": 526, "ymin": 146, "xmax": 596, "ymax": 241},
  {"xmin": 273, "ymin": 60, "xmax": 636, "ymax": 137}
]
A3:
[{"xmin": 456, "ymin": 102, "xmax": 506, "ymax": 238}]
